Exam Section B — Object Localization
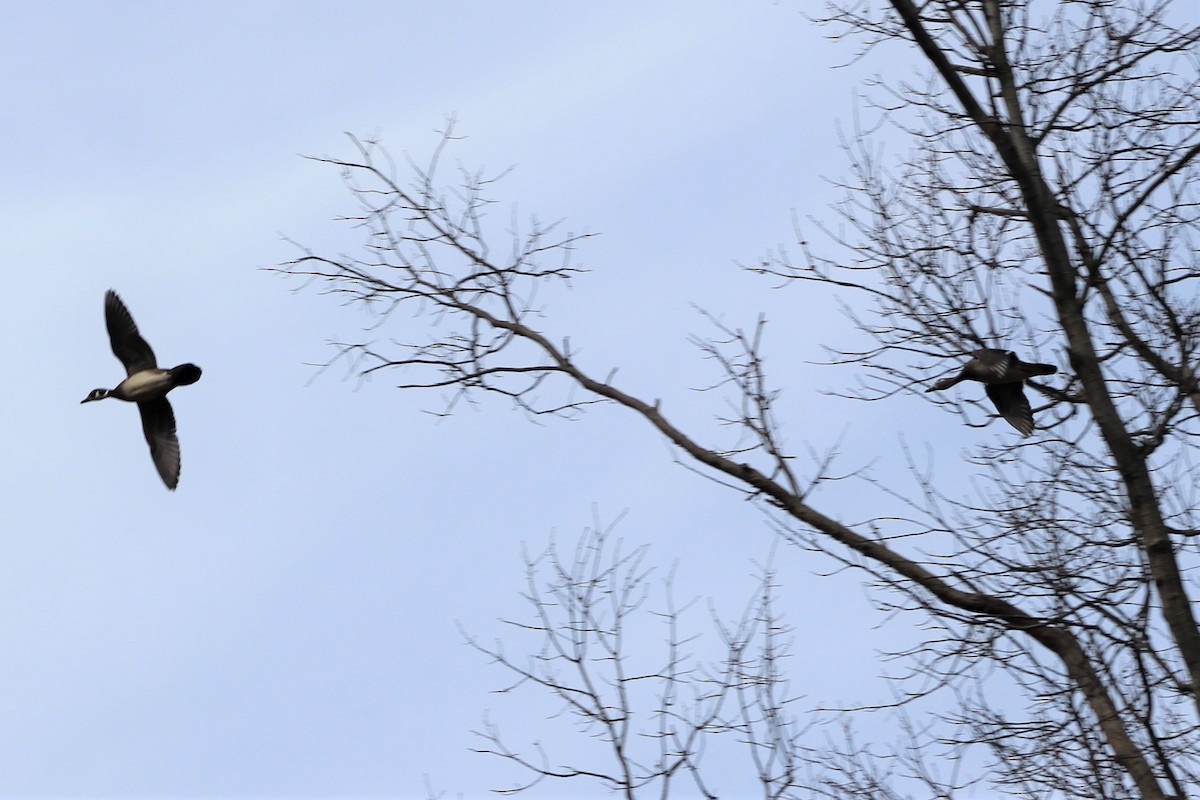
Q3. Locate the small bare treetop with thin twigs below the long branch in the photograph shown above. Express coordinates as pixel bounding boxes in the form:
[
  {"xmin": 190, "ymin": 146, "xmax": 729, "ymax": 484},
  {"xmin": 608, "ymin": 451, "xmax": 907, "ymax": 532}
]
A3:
[{"xmin": 467, "ymin": 521, "xmax": 800, "ymax": 798}]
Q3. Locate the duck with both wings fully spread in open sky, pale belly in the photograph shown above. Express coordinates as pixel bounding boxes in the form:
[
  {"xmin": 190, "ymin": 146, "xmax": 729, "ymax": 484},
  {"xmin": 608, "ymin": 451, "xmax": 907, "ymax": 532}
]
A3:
[{"xmin": 82, "ymin": 289, "xmax": 200, "ymax": 492}]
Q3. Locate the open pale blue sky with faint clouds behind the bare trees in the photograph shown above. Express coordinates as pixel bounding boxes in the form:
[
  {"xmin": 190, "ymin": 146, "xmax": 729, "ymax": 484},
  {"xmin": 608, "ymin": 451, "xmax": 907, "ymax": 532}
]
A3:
[{"xmin": 0, "ymin": 0, "xmax": 964, "ymax": 798}]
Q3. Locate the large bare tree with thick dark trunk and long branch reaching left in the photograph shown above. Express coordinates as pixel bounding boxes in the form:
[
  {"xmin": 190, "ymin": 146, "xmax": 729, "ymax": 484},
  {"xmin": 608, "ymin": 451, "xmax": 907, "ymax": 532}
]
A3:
[{"xmin": 282, "ymin": 0, "xmax": 1200, "ymax": 800}]
